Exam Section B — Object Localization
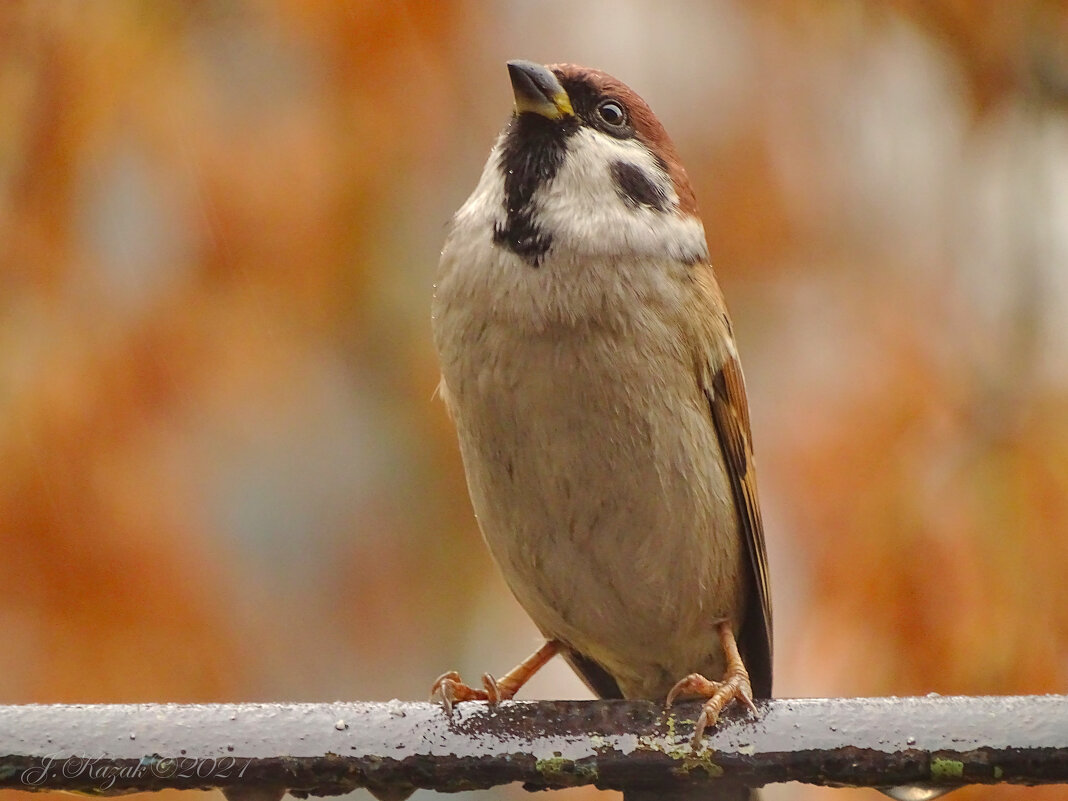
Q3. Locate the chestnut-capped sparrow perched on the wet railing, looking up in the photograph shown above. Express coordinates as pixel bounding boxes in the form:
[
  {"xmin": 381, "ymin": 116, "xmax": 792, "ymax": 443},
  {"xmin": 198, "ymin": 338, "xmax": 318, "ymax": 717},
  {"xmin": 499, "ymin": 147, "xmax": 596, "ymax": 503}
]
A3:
[{"xmin": 431, "ymin": 61, "xmax": 772, "ymax": 801}]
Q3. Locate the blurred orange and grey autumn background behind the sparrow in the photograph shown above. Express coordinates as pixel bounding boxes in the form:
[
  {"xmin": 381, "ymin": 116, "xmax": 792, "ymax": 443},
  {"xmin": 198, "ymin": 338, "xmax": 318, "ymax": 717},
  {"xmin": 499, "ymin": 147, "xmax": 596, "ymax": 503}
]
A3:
[{"xmin": 0, "ymin": 0, "xmax": 1068, "ymax": 801}]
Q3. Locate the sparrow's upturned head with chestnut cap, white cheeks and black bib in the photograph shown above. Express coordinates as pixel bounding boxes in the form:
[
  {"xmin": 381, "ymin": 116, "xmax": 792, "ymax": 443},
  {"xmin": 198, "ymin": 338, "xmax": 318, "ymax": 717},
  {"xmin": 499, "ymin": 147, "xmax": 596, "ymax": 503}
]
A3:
[{"xmin": 458, "ymin": 61, "xmax": 708, "ymax": 267}]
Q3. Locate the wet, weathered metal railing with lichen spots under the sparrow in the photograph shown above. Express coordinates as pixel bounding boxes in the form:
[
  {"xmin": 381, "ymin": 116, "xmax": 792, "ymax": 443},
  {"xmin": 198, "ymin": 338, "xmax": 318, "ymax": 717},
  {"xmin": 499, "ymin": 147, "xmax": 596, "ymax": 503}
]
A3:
[{"xmin": 0, "ymin": 695, "xmax": 1068, "ymax": 799}]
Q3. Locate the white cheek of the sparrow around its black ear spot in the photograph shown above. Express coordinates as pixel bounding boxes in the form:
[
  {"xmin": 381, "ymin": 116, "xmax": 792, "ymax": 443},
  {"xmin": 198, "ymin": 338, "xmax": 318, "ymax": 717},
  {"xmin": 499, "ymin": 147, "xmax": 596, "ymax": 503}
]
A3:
[{"xmin": 534, "ymin": 128, "xmax": 708, "ymax": 262}]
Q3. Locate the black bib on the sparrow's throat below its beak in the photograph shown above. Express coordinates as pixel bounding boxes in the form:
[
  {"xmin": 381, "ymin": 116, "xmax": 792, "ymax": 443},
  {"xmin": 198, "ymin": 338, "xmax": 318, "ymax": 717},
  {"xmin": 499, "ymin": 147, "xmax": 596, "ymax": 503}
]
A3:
[{"xmin": 493, "ymin": 113, "xmax": 578, "ymax": 267}]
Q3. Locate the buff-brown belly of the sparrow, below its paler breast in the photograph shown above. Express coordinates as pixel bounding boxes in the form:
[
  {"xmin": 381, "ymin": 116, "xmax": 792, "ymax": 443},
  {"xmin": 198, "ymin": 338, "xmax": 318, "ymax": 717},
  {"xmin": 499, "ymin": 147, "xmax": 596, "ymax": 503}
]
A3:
[{"xmin": 445, "ymin": 334, "xmax": 747, "ymax": 697}]
